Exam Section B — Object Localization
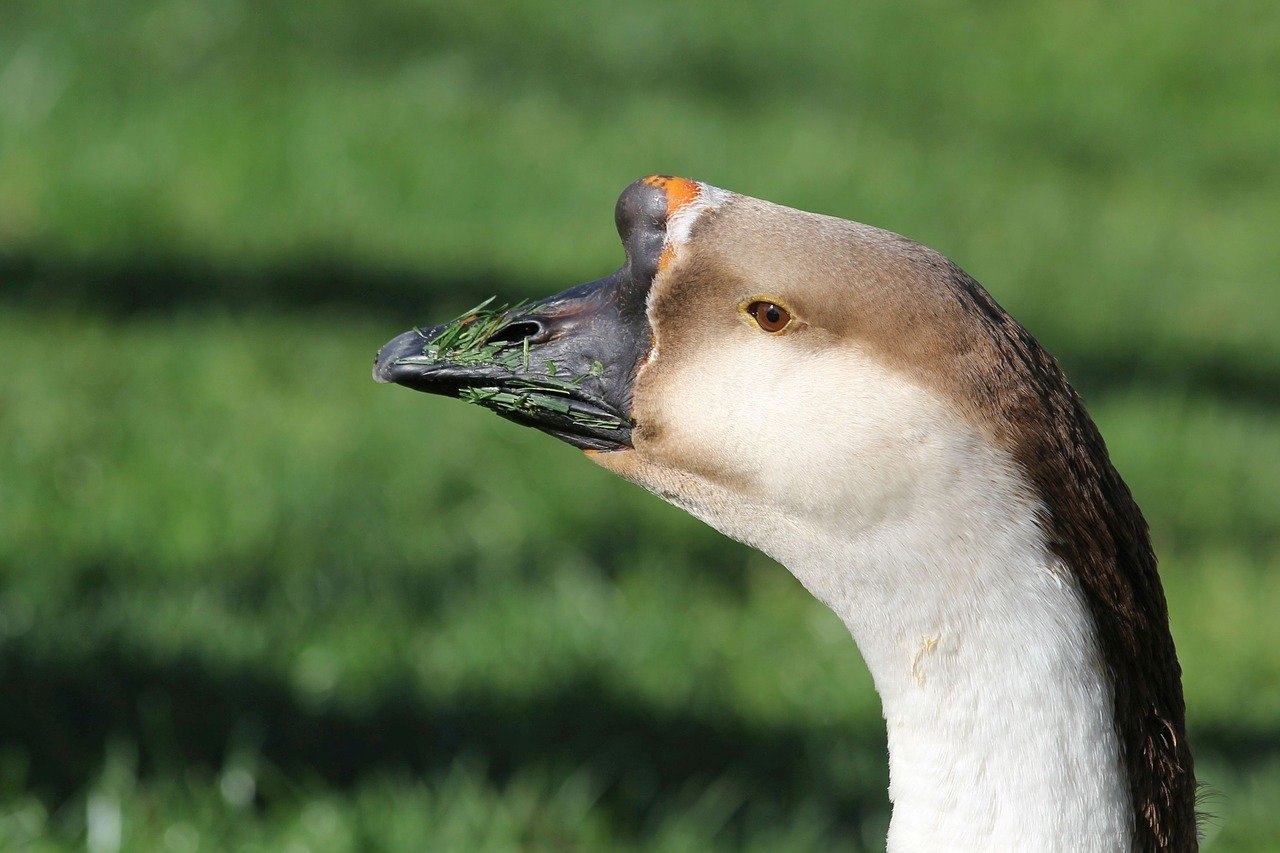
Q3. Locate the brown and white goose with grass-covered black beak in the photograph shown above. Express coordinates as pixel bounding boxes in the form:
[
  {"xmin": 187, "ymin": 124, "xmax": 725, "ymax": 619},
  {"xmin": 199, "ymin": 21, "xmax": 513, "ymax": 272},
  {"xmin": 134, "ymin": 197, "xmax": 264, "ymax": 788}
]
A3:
[{"xmin": 374, "ymin": 175, "xmax": 1198, "ymax": 850}]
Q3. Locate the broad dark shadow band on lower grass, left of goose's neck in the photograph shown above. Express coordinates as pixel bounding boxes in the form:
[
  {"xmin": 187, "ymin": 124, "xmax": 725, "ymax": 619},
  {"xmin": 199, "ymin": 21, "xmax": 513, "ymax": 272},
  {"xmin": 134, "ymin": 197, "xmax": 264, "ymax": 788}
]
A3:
[{"xmin": 0, "ymin": 642, "xmax": 887, "ymax": 839}]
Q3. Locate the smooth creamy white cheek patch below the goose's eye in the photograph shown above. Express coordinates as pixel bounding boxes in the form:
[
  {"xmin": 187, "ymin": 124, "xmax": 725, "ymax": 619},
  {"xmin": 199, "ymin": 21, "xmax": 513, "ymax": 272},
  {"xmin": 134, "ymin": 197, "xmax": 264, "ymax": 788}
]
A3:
[{"xmin": 645, "ymin": 333, "xmax": 954, "ymax": 526}]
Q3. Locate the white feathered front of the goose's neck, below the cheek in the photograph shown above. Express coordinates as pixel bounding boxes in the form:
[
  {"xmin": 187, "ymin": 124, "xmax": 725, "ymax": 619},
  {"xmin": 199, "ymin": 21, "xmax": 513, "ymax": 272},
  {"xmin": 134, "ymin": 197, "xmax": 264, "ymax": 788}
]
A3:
[{"xmin": 787, "ymin": 470, "xmax": 1132, "ymax": 850}]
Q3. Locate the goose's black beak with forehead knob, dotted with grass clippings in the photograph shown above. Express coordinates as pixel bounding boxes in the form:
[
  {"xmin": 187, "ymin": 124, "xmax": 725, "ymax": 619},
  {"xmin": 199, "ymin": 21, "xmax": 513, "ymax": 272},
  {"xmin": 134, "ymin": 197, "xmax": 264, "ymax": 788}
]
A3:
[{"xmin": 374, "ymin": 175, "xmax": 668, "ymax": 451}]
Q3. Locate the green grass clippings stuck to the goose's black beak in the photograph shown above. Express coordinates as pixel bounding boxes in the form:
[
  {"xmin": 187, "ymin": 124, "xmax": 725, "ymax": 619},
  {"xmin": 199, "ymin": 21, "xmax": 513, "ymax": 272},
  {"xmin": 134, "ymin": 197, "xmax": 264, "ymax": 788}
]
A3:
[{"xmin": 399, "ymin": 296, "xmax": 631, "ymax": 429}]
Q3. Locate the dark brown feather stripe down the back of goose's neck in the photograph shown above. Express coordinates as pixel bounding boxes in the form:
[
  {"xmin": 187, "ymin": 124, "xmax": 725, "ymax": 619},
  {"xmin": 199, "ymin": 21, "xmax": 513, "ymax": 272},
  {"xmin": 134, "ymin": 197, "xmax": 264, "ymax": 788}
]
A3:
[{"xmin": 946, "ymin": 261, "xmax": 1198, "ymax": 852}]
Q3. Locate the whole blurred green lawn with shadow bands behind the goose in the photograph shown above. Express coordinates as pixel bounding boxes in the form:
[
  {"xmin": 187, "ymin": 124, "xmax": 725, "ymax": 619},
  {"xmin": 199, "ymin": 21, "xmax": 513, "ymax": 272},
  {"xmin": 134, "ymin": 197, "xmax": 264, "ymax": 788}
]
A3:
[{"xmin": 0, "ymin": 0, "xmax": 1280, "ymax": 852}]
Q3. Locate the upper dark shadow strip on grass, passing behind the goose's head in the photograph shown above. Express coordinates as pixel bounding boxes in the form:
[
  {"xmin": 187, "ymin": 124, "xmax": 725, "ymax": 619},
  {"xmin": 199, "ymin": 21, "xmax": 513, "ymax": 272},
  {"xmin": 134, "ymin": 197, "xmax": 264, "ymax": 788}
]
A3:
[{"xmin": 0, "ymin": 254, "xmax": 1280, "ymax": 410}]
